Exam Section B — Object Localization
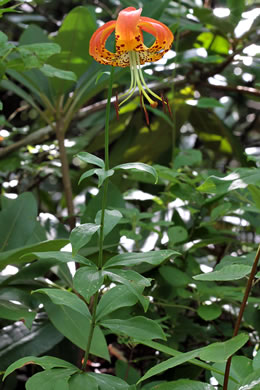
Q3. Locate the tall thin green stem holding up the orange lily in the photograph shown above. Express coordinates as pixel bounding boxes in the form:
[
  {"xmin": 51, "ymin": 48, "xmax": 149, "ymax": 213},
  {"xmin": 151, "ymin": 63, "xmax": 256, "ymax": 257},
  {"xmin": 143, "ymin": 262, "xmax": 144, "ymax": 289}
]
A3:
[{"xmin": 82, "ymin": 67, "xmax": 114, "ymax": 371}]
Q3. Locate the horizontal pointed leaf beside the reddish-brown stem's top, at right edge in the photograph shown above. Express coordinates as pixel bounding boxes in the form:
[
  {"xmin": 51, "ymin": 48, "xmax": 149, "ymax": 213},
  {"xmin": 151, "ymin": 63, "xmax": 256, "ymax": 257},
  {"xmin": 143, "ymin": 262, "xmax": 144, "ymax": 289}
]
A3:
[{"xmin": 193, "ymin": 264, "xmax": 251, "ymax": 281}]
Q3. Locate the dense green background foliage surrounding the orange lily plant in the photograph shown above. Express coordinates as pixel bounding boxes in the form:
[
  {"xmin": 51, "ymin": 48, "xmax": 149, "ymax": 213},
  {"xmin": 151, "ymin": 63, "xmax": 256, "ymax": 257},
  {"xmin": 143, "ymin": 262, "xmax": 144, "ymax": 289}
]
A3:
[{"xmin": 0, "ymin": 0, "xmax": 260, "ymax": 390}]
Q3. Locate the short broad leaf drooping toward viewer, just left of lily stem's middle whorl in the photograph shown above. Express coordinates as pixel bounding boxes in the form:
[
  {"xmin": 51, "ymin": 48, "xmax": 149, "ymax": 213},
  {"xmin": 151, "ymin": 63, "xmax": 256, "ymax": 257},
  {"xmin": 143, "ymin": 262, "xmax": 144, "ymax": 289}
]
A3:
[{"xmin": 73, "ymin": 267, "xmax": 104, "ymax": 302}]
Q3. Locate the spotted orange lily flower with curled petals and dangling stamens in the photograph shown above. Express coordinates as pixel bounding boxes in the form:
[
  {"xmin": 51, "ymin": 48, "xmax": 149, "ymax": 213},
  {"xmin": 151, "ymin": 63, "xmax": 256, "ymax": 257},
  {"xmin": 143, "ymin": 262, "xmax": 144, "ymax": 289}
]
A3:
[{"xmin": 89, "ymin": 7, "xmax": 173, "ymax": 111}]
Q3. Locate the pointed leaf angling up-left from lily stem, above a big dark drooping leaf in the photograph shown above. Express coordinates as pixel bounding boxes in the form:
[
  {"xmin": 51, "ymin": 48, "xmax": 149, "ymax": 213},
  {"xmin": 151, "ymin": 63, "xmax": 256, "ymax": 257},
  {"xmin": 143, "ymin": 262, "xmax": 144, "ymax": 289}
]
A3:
[{"xmin": 33, "ymin": 288, "xmax": 91, "ymax": 319}]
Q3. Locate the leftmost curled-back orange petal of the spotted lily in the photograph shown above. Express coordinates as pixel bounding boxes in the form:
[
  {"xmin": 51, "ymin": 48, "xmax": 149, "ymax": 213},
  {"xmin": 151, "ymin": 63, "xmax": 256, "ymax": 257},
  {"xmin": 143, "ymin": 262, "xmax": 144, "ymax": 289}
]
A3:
[{"xmin": 89, "ymin": 20, "xmax": 116, "ymax": 65}]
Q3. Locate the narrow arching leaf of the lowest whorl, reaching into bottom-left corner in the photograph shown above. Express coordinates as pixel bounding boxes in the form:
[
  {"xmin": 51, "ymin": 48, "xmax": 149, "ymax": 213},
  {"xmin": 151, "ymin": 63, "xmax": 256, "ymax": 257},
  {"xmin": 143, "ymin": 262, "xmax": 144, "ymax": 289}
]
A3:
[{"xmin": 3, "ymin": 356, "xmax": 77, "ymax": 379}]
